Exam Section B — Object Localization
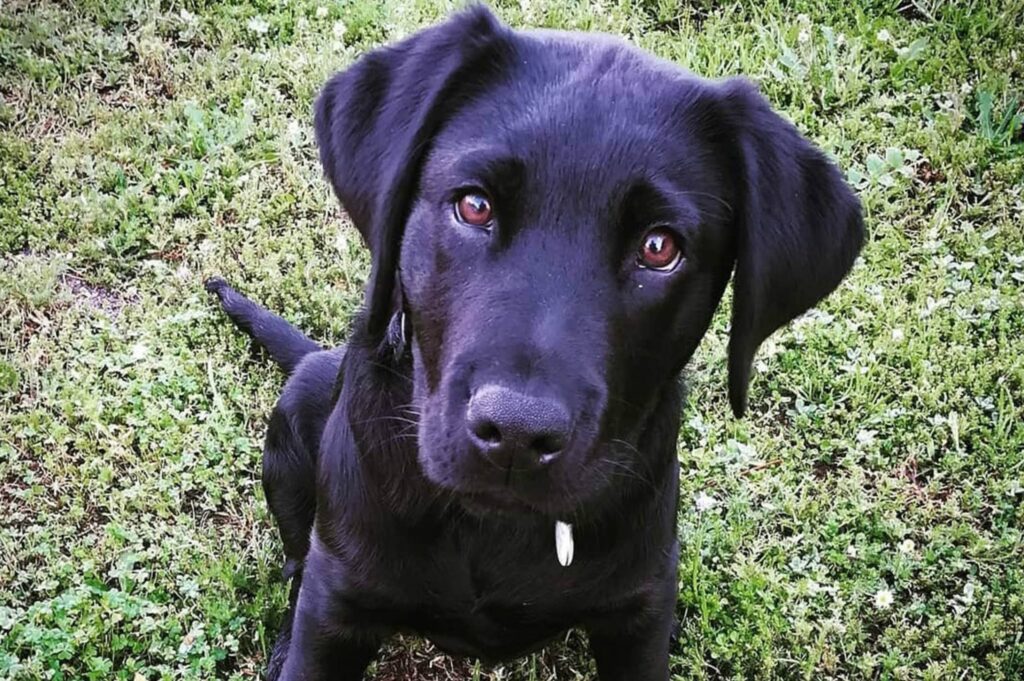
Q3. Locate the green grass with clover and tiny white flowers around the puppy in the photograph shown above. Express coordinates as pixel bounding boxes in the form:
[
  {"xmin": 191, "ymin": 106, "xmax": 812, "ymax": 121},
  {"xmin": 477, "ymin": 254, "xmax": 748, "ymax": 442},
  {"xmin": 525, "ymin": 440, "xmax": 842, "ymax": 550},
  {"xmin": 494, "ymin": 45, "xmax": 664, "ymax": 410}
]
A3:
[{"xmin": 0, "ymin": 0, "xmax": 1024, "ymax": 681}]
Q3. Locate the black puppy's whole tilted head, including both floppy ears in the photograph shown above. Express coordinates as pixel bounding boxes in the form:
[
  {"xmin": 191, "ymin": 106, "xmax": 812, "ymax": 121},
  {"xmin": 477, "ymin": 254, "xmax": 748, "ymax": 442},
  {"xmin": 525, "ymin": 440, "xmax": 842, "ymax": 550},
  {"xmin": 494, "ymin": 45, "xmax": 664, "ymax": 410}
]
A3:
[{"xmin": 315, "ymin": 8, "xmax": 863, "ymax": 515}]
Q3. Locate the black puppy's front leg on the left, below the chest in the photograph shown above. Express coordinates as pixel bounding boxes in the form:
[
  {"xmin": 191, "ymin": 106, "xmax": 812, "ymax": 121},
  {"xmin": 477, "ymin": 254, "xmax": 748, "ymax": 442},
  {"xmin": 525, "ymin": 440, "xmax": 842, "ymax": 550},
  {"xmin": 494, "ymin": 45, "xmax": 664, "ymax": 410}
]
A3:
[{"xmin": 280, "ymin": 576, "xmax": 383, "ymax": 681}]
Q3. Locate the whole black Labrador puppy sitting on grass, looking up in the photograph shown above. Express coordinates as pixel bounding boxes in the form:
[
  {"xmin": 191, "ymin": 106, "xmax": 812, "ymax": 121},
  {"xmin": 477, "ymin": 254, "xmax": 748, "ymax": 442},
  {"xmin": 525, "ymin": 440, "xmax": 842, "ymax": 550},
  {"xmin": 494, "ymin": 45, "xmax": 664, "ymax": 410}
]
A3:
[{"xmin": 208, "ymin": 8, "xmax": 863, "ymax": 681}]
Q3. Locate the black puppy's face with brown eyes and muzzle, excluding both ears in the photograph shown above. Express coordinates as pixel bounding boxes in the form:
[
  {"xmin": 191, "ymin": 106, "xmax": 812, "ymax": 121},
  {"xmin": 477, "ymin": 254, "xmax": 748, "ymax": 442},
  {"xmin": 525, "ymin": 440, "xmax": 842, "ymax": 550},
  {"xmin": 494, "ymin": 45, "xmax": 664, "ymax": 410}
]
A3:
[{"xmin": 400, "ymin": 51, "xmax": 734, "ymax": 511}]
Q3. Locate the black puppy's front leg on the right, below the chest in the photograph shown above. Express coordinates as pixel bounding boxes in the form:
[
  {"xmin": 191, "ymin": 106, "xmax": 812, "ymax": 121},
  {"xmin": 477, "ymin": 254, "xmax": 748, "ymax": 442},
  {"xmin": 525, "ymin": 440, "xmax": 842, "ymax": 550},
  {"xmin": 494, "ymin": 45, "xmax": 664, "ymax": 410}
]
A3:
[{"xmin": 588, "ymin": 601, "xmax": 674, "ymax": 681}]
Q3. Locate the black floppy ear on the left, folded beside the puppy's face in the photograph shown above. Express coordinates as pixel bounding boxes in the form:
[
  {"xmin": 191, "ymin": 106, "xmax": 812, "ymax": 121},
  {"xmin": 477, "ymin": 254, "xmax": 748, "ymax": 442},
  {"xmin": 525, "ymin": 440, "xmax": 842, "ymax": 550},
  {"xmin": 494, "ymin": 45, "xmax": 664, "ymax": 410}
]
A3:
[{"xmin": 314, "ymin": 6, "xmax": 511, "ymax": 338}]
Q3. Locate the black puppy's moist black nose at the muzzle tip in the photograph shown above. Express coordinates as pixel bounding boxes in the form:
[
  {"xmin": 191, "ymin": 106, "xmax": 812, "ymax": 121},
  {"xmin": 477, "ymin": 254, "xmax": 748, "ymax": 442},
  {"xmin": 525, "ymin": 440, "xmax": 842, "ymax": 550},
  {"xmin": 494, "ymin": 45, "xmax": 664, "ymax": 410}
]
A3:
[{"xmin": 466, "ymin": 385, "xmax": 570, "ymax": 471}]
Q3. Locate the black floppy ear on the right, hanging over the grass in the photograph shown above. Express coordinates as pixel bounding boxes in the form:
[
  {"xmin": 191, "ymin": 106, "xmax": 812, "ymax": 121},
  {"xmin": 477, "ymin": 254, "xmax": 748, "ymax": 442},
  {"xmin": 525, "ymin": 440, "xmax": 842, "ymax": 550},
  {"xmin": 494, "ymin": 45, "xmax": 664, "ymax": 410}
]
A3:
[{"xmin": 721, "ymin": 79, "xmax": 864, "ymax": 417}]
